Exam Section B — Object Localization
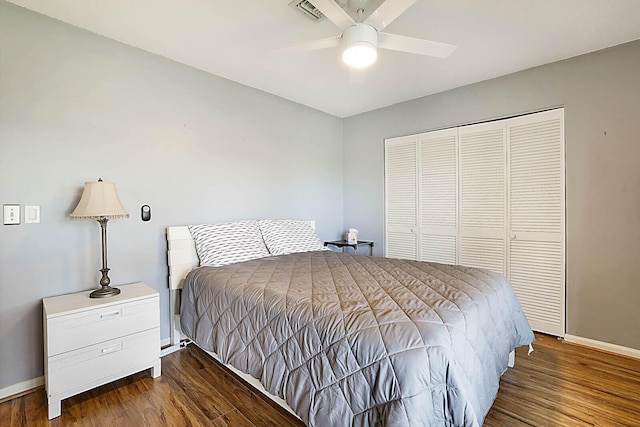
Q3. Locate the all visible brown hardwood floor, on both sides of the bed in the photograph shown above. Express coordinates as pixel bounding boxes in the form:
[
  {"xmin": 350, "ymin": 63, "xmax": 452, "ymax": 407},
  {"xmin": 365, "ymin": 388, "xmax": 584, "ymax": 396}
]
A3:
[{"xmin": 0, "ymin": 335, "xmax": 640, "ymax": 427}]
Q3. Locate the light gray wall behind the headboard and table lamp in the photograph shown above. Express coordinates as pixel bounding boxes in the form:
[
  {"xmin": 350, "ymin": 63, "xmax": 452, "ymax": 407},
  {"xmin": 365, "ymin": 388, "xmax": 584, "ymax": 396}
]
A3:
[{"xmin": 0, "ymin": 1, "xmax": 343, "ymax": 389}]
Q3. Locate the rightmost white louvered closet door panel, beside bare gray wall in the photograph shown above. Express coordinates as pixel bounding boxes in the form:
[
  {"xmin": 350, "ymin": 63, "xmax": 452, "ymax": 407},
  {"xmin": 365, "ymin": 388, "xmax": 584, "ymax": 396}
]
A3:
[{"xmin": 507, "ymin": 109, "xmax": 565, "ymax": 336}]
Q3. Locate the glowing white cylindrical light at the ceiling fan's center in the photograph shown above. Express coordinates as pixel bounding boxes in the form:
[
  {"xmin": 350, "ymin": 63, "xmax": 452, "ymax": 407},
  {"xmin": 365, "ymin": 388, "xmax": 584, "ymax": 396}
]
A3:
[{"xmin": 342, "ymin": 24, "xmax": 378, "ymax": 68}]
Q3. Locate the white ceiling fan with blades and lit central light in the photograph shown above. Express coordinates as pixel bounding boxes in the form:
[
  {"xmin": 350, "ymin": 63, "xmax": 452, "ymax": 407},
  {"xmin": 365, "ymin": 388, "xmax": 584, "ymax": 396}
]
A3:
[{"xmin": 281, "ymin": 0, "xmax": 456, "ymax": 68}]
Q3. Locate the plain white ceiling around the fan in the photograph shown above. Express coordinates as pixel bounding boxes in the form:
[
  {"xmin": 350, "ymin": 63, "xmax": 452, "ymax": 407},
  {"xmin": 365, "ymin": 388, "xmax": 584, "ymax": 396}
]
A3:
[{"xmin": 10, "ymin": 0, "xmax": 640, "ymax": 117}]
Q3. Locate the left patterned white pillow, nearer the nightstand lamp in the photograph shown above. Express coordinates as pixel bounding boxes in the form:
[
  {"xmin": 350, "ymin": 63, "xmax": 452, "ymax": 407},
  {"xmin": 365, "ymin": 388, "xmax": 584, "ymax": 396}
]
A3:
[{"xmin": 189, "ymin": 220, "xmax": 269, "ymax": 267}]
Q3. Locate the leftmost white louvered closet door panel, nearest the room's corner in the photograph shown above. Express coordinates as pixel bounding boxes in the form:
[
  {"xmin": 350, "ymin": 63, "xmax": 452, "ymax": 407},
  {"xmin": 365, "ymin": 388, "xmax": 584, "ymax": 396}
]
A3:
[{"xmin": 385, "ymin": 135, "xmax": 418, "ymax": 259}]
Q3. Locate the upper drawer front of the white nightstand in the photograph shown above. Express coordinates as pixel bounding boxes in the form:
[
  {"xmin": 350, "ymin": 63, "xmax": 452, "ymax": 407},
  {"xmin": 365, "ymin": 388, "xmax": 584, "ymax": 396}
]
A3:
[{"xmin": 47, "ymin": 296, "xmax": 160, "ymax": 357}]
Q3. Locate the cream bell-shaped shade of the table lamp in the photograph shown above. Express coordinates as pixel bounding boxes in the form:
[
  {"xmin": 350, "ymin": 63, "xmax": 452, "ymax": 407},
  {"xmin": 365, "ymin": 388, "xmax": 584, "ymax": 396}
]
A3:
[{"xmin": 70, "ymin": 180, "xmax": 129, "ymax": 219}]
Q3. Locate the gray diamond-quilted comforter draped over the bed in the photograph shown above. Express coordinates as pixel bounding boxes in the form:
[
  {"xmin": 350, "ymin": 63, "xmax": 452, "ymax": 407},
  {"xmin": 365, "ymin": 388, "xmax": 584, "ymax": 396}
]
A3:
[{"xmin": 181, "ymin": 251, "xmax": 534, "ymax": 427}]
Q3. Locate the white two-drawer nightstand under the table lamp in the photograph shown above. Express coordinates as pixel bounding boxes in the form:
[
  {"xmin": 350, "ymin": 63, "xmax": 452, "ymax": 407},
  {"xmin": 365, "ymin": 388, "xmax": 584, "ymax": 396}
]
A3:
[{"xmin": 42, "ymin": 283, "xmax": 160, "ymax": 419}]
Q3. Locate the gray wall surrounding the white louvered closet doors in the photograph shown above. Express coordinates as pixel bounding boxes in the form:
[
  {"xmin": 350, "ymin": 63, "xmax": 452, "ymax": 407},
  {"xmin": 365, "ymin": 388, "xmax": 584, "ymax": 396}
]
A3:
[{"xmin": 344, "ymin": 41, "xmax": 640, "ymax": 349}]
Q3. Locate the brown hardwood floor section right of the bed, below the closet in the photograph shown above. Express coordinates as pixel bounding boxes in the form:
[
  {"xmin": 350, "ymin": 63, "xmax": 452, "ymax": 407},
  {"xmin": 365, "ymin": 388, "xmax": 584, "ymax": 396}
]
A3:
[{"xmin": 485, "ymin": 334, "xmax": 640, "ymax": 427}]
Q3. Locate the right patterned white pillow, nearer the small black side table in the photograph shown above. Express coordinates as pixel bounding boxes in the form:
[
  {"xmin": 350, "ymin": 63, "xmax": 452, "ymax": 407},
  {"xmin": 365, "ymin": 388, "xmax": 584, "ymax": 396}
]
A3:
[{"xmin": 258, "ymin": 219, "xmax": 327, "ymax": 255}]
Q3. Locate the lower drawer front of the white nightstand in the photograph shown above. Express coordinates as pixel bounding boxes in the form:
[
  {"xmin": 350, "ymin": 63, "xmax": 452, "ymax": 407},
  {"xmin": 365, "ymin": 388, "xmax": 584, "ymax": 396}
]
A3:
[{"xmin": 47, "ymin": 328, "xmax": 160, "ymax": 396}]
